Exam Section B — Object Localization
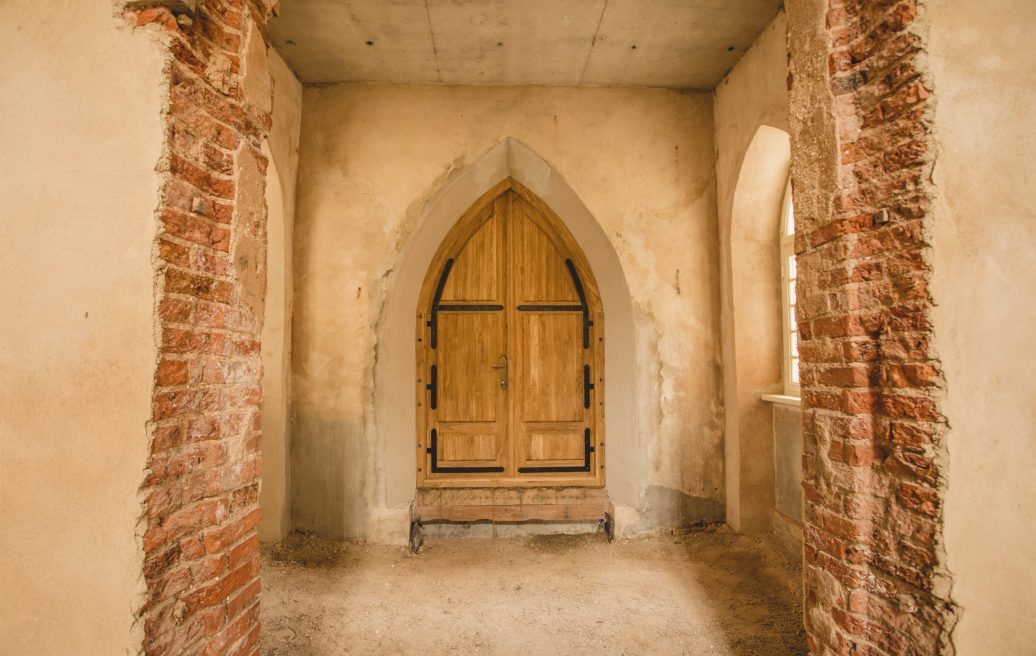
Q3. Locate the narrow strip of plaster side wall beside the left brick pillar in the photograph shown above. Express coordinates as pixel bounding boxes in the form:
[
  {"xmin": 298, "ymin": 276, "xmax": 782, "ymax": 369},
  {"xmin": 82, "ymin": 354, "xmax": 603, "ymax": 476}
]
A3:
[{"xmin": 259, "ymin": 49, "xmax": 303, "ymax": 542}]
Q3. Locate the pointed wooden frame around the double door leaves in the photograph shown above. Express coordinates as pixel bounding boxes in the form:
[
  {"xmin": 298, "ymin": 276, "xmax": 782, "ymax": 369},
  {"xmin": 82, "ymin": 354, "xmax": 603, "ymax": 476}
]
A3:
[{"xmin": 414, "ymin": 177, "xmax": 607, "ymax": 488}]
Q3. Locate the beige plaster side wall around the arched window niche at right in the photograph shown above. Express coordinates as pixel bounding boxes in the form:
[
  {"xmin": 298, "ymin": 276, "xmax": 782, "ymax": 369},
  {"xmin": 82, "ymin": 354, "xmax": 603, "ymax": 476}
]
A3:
[{"xmin": 715, "ymin": 12, "xmax": 792, "ymax": 532}]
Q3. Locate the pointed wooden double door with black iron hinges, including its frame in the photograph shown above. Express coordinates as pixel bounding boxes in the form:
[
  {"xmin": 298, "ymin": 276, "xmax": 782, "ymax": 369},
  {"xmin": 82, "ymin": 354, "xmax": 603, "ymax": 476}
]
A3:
[{"xmin": 416, "ymin": 179, "xmax": 604, "ymax": 487}]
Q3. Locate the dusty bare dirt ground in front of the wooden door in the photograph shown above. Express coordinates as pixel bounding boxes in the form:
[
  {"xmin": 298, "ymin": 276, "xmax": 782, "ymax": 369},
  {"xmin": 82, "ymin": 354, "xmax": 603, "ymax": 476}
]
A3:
[{"xmin": 256, "ymin": 530, "xmax": 805, "ymax": 656}]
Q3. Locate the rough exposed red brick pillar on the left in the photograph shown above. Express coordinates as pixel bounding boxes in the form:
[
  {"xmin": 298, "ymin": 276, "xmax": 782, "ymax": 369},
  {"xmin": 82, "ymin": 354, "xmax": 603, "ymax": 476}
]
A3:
[{"xmin": 126, "ymin": 0, "xmax": 270, "ymax": 655}]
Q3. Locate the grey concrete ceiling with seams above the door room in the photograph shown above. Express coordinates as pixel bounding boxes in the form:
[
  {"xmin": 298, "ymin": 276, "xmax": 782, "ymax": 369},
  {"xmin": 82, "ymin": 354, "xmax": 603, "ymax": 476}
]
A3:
[{"xmin": 270, "ymin": 0, "xmax": 781, "ymax": 89}]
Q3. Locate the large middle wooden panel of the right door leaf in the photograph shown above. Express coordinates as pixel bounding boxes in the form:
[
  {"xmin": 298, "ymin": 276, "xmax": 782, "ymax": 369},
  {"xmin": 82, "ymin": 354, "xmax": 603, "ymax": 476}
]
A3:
[{"xmin": 518, "ymin": 311, "xmax": 585, "ymax": 422}]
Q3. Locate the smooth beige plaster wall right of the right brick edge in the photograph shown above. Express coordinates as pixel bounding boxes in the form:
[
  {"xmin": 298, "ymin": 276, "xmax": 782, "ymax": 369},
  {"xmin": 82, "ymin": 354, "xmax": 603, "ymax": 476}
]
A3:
[{"xmin": 928, "ymin": 0, "xmax": 1036, "ymax": 656}]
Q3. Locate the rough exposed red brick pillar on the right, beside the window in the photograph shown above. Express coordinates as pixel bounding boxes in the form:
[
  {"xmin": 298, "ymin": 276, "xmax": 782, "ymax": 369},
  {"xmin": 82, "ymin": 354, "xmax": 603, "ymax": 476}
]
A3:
[{"xmin": 787, "ymin": 0, "xmax": 956, "ymax": 656}]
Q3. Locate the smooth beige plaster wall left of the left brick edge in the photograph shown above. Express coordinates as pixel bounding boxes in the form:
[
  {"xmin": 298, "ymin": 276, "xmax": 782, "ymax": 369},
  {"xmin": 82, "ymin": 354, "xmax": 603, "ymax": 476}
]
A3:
[{"xmin": 0, "ymin": 0, "xmax": 164, "ymax": 656}]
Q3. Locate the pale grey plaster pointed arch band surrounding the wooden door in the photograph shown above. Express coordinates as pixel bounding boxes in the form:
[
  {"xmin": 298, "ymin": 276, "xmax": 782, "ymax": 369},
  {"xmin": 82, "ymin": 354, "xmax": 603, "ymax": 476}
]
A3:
[{"xmin": 371, "ymin": 138, "xmax": 643, "ymax": 522}]
